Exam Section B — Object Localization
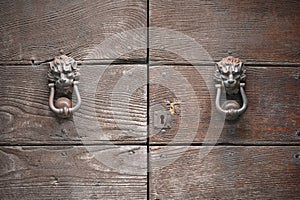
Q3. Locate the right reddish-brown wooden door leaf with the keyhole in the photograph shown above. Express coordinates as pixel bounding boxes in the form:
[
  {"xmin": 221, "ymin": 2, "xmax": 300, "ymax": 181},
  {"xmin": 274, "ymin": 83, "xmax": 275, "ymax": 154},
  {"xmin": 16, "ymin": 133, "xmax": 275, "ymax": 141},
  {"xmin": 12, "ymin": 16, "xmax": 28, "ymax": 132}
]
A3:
[{"xmin": 149, "ymin": 0, "xmax": 300, "ymax": 199}]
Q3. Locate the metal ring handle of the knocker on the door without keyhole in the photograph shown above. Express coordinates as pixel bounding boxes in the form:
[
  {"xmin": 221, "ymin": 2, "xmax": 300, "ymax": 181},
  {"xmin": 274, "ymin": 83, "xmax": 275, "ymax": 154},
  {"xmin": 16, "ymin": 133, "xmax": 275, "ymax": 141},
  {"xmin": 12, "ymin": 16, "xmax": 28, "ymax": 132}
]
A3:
[{"xmin": 49, "ymin": 81, "xmax": 81, "ymax": 117}]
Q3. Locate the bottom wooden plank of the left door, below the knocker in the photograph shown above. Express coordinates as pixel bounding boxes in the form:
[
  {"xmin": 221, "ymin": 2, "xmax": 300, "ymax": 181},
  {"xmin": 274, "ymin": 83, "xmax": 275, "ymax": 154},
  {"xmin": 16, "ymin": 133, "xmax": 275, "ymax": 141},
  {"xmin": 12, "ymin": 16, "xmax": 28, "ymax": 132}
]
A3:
[{"xmin": 0, "ymin": 145, "xmax": 147, "ymax": 199}]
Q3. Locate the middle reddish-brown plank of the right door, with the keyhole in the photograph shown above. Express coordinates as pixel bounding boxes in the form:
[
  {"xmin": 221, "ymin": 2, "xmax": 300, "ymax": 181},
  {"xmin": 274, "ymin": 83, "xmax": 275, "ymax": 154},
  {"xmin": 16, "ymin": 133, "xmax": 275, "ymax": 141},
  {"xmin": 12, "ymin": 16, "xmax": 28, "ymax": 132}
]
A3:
[{"xmin": 150, "ymin": 66, "xmax": 300, "ymax": 145}]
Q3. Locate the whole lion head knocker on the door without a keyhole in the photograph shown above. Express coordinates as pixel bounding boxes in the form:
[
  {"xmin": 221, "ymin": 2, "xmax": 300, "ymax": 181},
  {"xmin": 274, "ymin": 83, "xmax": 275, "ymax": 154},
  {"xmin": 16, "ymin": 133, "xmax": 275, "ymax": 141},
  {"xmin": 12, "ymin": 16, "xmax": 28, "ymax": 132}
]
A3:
[{"xmin": 48, "ymin": 52, "xmax": 81, "ymax": 118}]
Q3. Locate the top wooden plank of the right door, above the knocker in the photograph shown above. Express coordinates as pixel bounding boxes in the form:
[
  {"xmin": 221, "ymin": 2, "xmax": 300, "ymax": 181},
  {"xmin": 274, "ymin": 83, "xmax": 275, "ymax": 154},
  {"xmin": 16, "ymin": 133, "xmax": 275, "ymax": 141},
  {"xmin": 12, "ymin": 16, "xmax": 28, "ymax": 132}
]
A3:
[{"xmin": 150, "ymin": 0, "xmax": 300, "ymax": 63}]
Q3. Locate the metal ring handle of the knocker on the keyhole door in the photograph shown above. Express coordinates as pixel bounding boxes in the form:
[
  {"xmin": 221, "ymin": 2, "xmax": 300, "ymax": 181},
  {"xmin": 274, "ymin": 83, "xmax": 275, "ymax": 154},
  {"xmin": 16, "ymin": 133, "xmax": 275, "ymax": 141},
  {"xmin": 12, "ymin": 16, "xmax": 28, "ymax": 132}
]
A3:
[{"xmin": 216, "ymin": 83, "xmax": 248, "ymax": 119}]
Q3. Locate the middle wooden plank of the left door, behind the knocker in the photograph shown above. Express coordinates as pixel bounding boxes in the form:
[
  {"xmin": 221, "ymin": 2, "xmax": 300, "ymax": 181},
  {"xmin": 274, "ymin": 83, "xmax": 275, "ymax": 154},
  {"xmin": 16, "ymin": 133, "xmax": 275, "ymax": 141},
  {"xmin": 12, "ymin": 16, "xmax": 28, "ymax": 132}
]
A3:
[{"xmin": 0, "ymin": 64, "xmax": 147, "ymax": 144}]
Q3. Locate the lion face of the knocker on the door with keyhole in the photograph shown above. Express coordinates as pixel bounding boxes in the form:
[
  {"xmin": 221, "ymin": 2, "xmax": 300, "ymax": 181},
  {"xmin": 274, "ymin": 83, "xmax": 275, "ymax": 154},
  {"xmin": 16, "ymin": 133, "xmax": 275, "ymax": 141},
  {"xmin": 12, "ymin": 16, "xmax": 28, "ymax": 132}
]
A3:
[{"xmin": 215, "ymin": 56, "xmax": 246, "ymax": 94}]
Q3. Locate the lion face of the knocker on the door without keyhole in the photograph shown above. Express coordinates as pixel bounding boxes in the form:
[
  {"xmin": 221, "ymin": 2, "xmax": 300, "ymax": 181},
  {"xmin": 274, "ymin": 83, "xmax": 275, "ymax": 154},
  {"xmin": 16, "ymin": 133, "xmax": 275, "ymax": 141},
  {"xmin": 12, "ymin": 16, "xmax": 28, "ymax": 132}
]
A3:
[{"xmin": 48, "ymin": 55, "xmax": 80, "ymax": 93}]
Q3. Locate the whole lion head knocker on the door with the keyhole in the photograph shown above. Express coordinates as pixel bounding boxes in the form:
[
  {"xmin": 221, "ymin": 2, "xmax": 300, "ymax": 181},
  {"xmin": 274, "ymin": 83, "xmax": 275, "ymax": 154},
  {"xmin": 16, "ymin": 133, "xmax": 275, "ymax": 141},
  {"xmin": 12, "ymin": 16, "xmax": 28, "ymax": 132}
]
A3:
[{"xmin": 214, "ymin": 56, "xmax": 248, "ymax": 120}]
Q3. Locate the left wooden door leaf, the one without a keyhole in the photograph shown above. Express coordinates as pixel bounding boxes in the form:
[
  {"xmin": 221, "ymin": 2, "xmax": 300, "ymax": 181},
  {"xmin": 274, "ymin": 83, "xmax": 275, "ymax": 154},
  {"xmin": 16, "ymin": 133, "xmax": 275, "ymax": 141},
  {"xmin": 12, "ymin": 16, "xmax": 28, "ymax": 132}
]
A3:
[{"xmin": 0, "ymin": 0, "xmax": 147, "ymax": 199}]
